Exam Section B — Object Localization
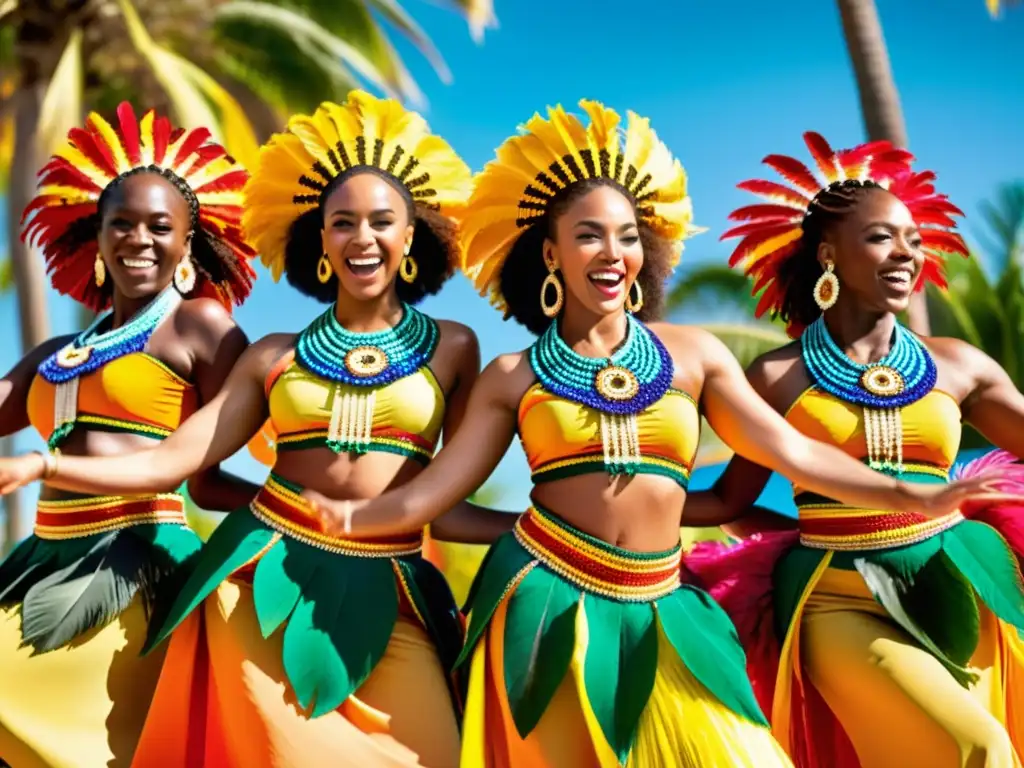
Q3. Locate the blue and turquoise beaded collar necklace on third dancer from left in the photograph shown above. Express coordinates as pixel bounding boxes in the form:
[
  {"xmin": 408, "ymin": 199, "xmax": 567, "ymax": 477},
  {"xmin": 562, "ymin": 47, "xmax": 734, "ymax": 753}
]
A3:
[{"xmin": 529, "ymin": 315, "xmax": 673, "ymax": 475}]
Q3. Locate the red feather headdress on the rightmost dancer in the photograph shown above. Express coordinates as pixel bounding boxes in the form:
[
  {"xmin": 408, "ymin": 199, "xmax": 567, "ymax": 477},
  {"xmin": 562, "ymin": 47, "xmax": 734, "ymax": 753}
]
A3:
[{"xmin": 722, "ymin": 132, "xmax": 968, "ymax": 337}]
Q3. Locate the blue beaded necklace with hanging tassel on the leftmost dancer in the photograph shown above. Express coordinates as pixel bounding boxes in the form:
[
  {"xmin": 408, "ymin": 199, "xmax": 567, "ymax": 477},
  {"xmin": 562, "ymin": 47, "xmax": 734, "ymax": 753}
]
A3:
[{"xmin": 37, "ymin": 286, "xmax": 182, "ymax": 450}]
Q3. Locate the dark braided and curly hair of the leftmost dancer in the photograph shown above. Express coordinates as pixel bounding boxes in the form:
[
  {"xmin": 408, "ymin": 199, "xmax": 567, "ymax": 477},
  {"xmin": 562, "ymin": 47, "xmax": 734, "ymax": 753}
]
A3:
[{"xmin": 54, "ymin": 171, "xmax": 234, "ymax": 301}]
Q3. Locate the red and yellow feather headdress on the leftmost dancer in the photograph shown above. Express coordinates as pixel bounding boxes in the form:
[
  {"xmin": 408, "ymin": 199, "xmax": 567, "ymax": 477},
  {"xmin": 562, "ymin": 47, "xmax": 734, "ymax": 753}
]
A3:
[{"xmin": 22, "ymin": 102, "xmax": 256, "ymax": 311}]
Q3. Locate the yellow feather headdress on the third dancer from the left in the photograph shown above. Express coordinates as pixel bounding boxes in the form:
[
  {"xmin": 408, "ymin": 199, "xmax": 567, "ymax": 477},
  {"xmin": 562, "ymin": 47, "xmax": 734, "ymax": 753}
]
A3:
[{"xmin": 460, "ymin": 99, "xmax": 700, "ymax": 310}]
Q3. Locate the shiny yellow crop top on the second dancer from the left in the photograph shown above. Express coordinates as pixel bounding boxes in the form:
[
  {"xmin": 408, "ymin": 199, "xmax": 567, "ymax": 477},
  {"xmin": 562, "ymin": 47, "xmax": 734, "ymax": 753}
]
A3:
[{"xmin": 258, "ymin": 351, "xmax": 444, "ymax": 464}]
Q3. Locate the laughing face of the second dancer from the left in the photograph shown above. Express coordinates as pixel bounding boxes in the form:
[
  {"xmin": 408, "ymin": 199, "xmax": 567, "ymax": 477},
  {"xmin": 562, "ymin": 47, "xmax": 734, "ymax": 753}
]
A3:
[{"xmin": 323, "ymin": 173, "xmax": 413, "ymax": 301}]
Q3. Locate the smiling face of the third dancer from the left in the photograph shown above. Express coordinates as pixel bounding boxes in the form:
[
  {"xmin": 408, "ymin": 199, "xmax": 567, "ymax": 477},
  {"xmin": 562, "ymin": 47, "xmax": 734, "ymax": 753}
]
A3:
[{"xmin": 544, "ymin": 186, "xmax": 643, "ymax": 315}]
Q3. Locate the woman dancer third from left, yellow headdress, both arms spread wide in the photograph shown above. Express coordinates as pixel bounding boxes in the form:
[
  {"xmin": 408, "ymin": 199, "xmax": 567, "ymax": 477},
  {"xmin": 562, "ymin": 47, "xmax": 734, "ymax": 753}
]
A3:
[{"xmin": 290, "ymin": 101, "xmax": 999, "ymax": 768}]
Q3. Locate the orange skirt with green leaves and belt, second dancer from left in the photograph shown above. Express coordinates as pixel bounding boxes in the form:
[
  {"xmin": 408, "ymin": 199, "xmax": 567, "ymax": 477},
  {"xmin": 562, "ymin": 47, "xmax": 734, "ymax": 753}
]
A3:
[{"xmin": 134, "ymin": 475, "xmax": 462, "ymax": 768}]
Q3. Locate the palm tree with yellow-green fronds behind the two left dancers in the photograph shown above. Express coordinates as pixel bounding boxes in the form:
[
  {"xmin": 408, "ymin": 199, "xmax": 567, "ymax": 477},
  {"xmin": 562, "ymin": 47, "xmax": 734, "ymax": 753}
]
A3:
[{"xmin": 0, "ymin": 0, "xmax": 495, "ymax": 541}]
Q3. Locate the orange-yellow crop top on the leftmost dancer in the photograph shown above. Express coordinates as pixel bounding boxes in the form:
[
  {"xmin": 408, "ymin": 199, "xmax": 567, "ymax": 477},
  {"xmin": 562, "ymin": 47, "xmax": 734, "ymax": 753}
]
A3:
[{"xmin": 27, "ymin": 352, "xmax": 199, "ymax": 440}]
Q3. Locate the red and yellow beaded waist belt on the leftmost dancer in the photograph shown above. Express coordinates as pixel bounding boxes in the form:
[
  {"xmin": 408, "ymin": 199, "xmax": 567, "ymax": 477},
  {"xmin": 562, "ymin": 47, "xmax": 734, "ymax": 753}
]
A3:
[{"xmin": 34, "ymin": 494, "xmax": 187, "ymax": 540}]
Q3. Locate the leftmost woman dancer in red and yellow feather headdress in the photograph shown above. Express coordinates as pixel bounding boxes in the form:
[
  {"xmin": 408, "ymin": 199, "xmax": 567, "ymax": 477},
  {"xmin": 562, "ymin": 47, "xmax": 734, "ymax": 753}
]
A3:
[{"xmin": 0, "ymin": 103, "xmax": 256, "ymax": 767}]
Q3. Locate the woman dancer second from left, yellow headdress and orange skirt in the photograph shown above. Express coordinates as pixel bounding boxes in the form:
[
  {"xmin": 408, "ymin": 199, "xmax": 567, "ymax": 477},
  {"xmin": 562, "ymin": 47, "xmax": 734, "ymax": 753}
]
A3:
[{"xmin": 0, "ymin": 91, "xmax": 499, "ymax": 768}]
